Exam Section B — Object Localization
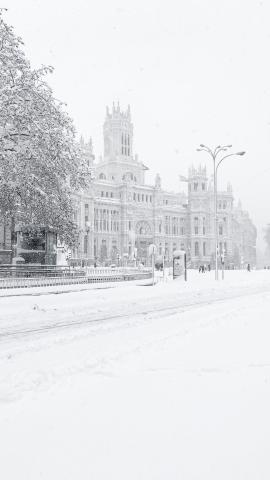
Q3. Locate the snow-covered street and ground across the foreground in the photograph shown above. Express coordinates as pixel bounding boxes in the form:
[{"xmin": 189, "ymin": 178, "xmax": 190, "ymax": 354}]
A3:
[{"xmin": 0, "ymin": 271, "xmax": 270, "ymax": 480}]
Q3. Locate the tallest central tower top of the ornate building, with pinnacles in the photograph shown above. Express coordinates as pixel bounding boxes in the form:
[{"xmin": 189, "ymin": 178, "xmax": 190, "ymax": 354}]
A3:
[{"xmin": 103, "ymin": 102, "xmax": 133, "ymax": 160}]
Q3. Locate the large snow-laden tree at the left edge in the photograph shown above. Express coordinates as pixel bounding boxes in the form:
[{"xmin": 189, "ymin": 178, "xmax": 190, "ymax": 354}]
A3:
[{"xmin": 0, "ymin": 11, "xmax": 90, "ymax": 245}]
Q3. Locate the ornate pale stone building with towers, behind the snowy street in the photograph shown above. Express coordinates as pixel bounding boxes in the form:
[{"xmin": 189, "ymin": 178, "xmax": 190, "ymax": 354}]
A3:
[{"xmin": 72, "ymin": 104, "xmax": 256, "ymax": 267}]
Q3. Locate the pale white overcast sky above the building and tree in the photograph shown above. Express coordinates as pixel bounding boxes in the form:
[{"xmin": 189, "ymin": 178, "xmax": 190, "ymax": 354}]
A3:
[{"xmin": 5, "ymin": 0, "xmax": 270, "ymax": 246}]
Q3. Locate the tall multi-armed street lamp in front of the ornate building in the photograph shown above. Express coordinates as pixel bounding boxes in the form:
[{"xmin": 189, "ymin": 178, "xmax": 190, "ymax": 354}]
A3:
[{"xmin": 197, "ymin": 144, "xmax": 245, "ymax": 280}]
